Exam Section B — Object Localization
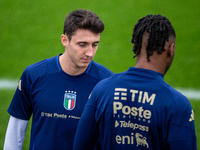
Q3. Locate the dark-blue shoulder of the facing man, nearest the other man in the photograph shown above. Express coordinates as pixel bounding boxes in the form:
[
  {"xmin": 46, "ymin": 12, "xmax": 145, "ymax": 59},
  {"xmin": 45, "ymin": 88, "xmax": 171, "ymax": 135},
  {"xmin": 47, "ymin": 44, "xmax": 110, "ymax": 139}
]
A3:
[{"xmin": 88, "ymin": 61, "xmax": 114, "ymax": 80}]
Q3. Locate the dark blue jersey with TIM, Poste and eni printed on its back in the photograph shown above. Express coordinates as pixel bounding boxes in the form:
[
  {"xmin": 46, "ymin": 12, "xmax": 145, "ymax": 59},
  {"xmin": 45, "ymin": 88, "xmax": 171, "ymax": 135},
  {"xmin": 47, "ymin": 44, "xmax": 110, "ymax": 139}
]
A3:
[{"xmin": 74, "ymin": 67, "xmax": 197, "ymax": 150}]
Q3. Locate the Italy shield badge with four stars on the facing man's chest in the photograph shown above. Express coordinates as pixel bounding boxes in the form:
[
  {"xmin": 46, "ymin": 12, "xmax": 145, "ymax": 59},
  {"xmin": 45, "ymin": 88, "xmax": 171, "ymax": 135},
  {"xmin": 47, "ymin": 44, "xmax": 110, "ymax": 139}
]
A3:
[{"xmin": 63, "ymin": 91, "xmax": 76, "ymax": 110}]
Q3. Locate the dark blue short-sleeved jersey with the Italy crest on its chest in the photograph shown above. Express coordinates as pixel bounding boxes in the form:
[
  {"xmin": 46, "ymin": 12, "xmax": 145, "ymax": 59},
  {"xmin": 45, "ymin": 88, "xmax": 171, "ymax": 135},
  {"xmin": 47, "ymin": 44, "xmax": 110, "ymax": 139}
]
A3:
[{"xmin": 8, "ymin": 56, "xmax": 113, "ymax": 150}]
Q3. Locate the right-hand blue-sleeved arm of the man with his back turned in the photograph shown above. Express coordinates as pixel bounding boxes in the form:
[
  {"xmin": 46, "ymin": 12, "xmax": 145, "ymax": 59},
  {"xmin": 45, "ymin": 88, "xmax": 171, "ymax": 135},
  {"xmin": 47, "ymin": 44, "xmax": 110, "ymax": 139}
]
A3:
[{"xmin": 168, "ymin": 88, "xmax": 197, "ymax": 150}]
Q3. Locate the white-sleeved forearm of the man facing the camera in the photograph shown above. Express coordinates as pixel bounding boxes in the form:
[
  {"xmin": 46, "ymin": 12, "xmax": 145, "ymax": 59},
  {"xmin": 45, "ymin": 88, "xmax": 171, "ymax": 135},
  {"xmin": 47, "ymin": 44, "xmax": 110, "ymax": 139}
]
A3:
[{"xmin": 4, "ymin": 116, "xmax": 29, "ymax": 150}]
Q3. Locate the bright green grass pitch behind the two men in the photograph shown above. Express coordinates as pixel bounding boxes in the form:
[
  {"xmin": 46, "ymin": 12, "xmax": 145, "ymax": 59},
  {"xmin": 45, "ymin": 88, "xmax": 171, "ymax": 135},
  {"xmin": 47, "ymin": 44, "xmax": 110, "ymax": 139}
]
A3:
[{"xmin": 0, "ymin": 0, "xmax": 200, "ymax": 150}]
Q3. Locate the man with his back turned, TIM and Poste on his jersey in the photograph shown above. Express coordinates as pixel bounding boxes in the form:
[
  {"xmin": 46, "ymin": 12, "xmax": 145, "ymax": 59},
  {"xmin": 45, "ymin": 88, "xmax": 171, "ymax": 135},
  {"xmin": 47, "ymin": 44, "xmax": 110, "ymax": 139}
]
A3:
[{"xmin": 74, "ymin": 15, "xmax": 197, "ymax": 150}]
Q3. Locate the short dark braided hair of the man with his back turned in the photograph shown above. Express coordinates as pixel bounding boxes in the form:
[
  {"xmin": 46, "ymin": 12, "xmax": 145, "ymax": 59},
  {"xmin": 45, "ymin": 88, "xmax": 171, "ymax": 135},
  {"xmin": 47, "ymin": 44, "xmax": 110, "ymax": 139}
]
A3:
[{"xmin": 131, "ymin": 15, "xmax": 176, "ymax": 61}]
